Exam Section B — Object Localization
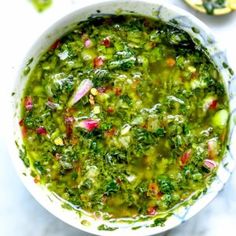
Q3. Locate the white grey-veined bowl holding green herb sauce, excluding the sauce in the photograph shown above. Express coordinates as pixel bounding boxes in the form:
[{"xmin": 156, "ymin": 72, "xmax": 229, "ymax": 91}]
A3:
[{"xmin": 8, "ymin": 0, "xmax": 236, "ymax": 236}]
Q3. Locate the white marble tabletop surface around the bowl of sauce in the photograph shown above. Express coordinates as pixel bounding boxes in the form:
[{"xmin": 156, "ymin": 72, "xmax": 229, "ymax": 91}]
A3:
[{"xmin": 0, "ymin": 0, "xmax": 236, "ymax": 236}]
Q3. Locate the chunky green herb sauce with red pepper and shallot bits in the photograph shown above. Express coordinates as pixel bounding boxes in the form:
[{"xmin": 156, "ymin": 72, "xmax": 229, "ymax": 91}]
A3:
[{"xmin": 19, "ymin": 15, "xmax": 228, "ymax": 218}]
